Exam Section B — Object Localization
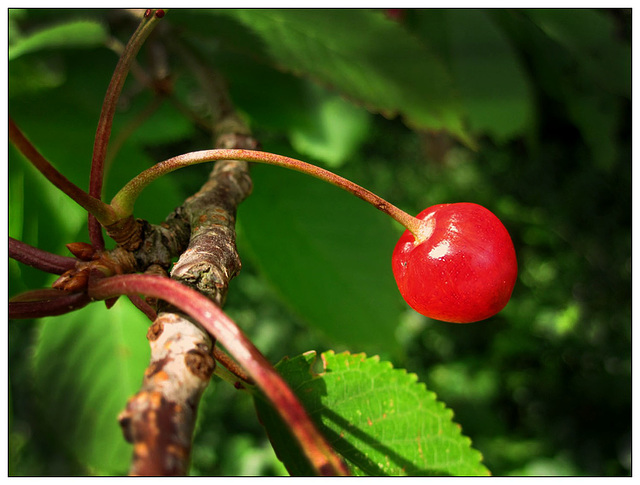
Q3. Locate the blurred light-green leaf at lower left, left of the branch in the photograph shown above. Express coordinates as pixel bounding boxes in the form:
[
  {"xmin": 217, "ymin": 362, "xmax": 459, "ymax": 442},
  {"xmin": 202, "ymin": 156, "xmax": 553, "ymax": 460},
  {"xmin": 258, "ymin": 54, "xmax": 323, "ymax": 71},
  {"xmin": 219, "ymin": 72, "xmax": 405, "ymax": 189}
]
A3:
[{"xmin": 33, "ymin": 299, "xmax": 149, "ymax": 474}]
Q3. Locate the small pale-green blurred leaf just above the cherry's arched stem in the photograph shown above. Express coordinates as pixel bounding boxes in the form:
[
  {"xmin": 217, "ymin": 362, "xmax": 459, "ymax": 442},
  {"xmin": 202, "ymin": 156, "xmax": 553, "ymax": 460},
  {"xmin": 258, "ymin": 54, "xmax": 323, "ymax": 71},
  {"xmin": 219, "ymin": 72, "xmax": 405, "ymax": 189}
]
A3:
[{"xmin": 289, "ymin": 85, "xmax": 370, "ymax": 167}]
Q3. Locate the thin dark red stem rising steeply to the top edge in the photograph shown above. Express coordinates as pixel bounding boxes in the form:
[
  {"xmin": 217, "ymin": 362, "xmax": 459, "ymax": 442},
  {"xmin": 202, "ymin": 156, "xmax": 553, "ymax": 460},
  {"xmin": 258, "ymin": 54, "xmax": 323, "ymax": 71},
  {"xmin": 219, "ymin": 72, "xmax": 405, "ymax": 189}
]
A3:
[{"xmin": 88, "ymin": 10, "xmax": 164, "ymax": 250}]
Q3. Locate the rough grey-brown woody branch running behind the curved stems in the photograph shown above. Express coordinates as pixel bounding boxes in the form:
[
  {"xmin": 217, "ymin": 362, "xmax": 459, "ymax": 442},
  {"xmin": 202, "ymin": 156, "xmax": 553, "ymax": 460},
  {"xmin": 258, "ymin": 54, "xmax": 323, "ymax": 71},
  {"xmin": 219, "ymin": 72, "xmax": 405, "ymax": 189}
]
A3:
[{"xmin": 119, "ymin": 131, "xmax": 256, "ymax": 475}]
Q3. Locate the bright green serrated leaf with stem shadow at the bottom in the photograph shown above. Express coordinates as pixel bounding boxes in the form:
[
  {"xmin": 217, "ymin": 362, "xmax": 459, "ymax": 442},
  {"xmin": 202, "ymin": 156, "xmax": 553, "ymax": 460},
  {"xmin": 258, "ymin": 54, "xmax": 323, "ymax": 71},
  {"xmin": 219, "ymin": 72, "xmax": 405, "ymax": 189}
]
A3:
[{"xmin": 256, "ymin": 351, "xmax": 489, "ymax": 476}]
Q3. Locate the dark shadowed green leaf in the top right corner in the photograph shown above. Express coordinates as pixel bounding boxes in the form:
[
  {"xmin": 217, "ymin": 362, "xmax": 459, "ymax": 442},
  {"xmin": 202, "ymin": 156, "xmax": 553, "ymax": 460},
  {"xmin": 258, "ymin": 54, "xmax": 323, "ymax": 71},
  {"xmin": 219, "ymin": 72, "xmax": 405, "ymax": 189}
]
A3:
[{"xmin": 525, "ymin": 9, "xmax": 631, "ymax": 171}]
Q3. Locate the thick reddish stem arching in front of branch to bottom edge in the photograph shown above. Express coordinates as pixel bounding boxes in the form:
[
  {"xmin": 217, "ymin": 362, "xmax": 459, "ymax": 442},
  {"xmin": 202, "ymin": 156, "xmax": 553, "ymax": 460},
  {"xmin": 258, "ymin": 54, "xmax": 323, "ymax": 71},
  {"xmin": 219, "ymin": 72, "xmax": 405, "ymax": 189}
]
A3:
[{"xmin": 88, "ymin": 274, "xmax": 349, "ymax": 475}]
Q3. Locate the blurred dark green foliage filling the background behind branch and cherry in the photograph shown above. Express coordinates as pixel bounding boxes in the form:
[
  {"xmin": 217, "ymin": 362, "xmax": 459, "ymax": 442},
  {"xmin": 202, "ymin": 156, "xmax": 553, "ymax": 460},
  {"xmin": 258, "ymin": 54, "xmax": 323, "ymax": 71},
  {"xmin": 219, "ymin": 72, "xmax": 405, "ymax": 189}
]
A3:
[{"xmin": 8, "ymin": 9, "xmax": 631, "ymax": 476}]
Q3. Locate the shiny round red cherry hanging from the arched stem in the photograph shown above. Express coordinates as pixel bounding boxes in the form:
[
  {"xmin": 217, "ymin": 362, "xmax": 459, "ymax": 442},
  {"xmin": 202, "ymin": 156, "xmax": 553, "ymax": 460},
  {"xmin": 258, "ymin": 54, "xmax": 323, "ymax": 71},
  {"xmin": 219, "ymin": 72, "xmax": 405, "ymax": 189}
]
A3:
[{"xmin": 392, "ymin": 202, "xmax": 518, "ymax": 323}]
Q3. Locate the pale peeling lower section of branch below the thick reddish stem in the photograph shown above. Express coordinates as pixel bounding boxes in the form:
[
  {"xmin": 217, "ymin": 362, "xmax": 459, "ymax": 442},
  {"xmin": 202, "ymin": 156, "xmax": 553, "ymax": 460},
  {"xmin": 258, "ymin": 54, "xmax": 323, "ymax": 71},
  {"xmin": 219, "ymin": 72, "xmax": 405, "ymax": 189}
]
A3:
[{"xmin": 118, "ymin": 313, "xmax": 215, "ymax": 476}]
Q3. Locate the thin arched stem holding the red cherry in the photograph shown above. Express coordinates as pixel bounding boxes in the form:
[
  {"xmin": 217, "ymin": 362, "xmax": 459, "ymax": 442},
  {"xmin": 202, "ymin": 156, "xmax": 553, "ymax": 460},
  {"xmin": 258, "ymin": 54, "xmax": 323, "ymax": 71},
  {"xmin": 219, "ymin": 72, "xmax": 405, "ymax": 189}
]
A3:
[{"xmin": 111, "ymin": 149, "xmax": 423, "ymax": 239}]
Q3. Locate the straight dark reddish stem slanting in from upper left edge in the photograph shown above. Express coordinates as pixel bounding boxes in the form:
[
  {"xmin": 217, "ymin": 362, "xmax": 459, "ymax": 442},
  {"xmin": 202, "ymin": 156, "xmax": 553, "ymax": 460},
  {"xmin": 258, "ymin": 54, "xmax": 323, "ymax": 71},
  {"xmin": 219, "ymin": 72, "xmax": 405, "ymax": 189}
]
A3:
[{"xmin": 9, "ymin": 117, "xmax": 115, "ymax": 222}]
